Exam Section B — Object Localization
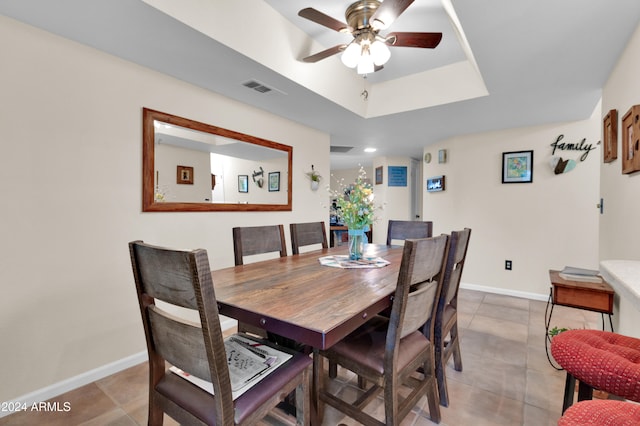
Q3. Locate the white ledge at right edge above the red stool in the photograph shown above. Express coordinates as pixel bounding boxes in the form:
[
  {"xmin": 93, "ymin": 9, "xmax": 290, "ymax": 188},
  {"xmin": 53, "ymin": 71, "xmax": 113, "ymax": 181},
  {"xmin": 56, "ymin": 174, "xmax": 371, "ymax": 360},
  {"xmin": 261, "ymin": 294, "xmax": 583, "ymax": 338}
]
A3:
[{"xmin": 600, "ymin": 260, "xmax": 640, "ymax": 338}]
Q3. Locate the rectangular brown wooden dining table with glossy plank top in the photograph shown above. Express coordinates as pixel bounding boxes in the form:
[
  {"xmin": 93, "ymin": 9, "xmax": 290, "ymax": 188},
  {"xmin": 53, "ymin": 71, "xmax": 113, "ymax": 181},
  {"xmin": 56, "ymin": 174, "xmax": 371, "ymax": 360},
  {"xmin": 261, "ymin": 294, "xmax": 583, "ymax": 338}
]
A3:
[{"xmin": 212, "ymin": 244, "xmax": 402, "ymax": 349}]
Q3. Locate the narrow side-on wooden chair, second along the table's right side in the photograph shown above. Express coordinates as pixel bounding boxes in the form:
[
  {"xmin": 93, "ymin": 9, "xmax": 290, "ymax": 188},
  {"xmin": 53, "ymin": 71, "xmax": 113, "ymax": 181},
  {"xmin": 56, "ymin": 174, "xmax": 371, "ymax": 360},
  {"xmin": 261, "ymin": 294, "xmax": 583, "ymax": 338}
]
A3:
[{"xmin": 434, "ymin": 228, "xmax": 471, "ymax": 407}]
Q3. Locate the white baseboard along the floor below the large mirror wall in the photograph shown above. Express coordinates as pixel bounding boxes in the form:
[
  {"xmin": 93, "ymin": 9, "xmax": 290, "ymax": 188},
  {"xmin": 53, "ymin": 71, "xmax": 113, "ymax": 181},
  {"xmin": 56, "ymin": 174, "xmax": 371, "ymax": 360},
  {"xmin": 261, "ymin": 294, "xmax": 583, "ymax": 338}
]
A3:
[{"xmin": 0, "ymin": 351, "xmax": 148, "ymax": 418}]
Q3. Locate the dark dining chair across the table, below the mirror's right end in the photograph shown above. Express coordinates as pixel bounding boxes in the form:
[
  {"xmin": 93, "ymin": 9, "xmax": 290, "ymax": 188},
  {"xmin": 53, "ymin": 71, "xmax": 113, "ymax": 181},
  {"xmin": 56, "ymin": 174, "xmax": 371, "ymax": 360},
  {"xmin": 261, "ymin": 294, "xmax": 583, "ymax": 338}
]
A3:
[{"xmin": 233, "ymin": 225, "xmax": 287, "ymax": 266}]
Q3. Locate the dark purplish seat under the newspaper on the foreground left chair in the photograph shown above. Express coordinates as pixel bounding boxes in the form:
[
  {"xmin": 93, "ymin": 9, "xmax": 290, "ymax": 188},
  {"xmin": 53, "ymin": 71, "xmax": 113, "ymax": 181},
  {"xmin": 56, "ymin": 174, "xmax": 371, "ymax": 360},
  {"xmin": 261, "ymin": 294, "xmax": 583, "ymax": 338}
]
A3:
[{"xmin": 156, "ymin": 354, "xmax": 312, "ymax": 424}]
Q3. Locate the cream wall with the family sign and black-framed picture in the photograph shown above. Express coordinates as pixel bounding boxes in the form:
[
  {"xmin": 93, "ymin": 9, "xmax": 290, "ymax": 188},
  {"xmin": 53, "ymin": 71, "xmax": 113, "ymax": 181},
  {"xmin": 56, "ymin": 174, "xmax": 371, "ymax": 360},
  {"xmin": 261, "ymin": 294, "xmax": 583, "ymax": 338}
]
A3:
[{"xmin": 423, "ymin": 106, "xmax": 602, "ymax": 298}]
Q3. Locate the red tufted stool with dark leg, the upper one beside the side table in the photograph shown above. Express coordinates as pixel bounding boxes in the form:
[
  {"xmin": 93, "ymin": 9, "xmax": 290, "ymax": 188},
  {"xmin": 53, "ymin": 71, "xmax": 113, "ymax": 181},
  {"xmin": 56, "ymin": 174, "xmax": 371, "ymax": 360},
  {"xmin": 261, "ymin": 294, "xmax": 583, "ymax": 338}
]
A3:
[{"xmin": 551, "ymin": 330, "xmax": 640, "ymax": 413}]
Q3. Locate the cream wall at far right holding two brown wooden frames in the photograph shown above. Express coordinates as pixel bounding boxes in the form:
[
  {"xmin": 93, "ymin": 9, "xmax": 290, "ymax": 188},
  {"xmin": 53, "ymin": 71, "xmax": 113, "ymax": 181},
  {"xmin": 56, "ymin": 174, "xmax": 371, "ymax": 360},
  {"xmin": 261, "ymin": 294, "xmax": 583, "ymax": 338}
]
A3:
[{"xmin": 600, "ymin": 23, "xmax": 640, "ymax": 337}]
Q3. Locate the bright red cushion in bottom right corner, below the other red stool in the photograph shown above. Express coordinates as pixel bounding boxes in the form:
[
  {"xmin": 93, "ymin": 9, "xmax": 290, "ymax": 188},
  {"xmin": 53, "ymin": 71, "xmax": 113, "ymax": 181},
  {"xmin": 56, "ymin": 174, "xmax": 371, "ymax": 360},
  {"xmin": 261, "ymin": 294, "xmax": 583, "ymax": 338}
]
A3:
[{"xmin": 558, "ymin": 399, "xmax": 640, "ymax": 426}]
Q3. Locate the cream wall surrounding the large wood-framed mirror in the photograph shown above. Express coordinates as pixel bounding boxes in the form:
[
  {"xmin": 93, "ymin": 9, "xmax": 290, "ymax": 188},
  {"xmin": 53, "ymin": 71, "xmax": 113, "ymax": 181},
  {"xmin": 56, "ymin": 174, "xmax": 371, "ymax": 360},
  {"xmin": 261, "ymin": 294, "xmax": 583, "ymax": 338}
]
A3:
[{"xmin": 0, "ymin": 17, "xmax": 329, "ymax": 401}]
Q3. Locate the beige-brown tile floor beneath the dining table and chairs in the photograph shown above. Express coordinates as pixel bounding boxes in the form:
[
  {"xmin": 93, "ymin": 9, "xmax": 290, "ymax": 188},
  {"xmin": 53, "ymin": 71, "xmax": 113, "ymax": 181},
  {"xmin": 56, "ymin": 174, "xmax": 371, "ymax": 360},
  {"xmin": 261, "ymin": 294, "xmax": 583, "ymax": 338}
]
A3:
[{"xmin": 0, "ymin": 289, "xmax": 601, "ymax": 426}]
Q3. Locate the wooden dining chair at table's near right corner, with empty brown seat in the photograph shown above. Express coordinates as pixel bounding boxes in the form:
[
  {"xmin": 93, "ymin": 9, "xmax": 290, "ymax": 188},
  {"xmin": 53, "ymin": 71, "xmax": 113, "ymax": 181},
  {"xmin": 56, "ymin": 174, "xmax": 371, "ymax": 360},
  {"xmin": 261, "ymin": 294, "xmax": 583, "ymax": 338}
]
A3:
[{"xmin": 315, "ymin": 235, "xmax": 448, "ymax": 426}]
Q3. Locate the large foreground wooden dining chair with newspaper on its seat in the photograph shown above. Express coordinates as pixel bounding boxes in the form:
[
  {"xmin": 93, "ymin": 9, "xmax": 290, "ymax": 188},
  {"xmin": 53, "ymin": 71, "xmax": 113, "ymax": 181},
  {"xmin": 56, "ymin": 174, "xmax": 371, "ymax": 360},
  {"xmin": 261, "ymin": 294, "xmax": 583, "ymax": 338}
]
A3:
[{"xmin": 129, "ymin": 241, "xmax": 311, "ymax": 425}]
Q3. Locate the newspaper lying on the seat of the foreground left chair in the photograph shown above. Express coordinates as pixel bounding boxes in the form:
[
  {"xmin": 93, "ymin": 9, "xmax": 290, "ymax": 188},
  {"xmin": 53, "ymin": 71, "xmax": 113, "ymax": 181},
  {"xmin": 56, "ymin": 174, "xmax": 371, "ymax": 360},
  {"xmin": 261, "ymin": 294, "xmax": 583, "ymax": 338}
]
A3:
[{"xmin": 169, "ymin": 334, "xmax": 292, "ymax": 400}]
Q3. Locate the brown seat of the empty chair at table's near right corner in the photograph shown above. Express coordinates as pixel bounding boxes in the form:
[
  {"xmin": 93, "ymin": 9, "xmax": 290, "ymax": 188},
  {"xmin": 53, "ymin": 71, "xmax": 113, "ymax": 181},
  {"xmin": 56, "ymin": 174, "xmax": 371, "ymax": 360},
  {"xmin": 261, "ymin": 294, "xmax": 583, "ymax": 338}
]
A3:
[{"xmin": 326, "ymin": 315, "xmax": 429, "ymax": 375}]
